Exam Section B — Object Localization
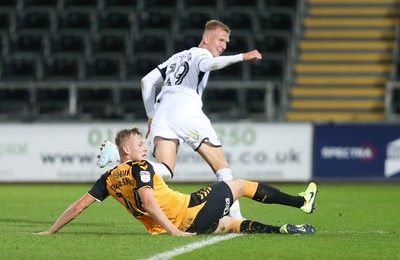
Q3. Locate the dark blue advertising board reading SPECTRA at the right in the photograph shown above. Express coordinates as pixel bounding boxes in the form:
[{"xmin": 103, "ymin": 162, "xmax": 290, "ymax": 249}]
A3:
[{"xmin": 313, "ymin": 124, "xmax": 400, "ymax": 180}]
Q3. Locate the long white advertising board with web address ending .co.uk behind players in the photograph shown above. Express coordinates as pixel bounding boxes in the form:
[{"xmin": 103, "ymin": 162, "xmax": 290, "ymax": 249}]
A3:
[{"xmin": 0, "ymin": 123, "xmax": 312, "ymax": 182}]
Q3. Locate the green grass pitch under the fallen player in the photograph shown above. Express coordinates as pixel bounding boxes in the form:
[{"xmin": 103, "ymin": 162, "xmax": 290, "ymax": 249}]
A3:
[{"xmin": 0, "ymin": 183, "xmax": 400, "ymax": 260}]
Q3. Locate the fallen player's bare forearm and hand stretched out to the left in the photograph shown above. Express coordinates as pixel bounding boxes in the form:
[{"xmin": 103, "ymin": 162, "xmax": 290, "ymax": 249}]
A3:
[{"xmin": 36, "ymin": 194, "xmax": 96, "ymax": 235}]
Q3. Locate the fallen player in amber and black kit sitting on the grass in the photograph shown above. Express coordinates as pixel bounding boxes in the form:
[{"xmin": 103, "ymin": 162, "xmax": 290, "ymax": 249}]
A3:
[{"xmin": 38, "ymin": 128, "xmax": 317, "ymax": 236}]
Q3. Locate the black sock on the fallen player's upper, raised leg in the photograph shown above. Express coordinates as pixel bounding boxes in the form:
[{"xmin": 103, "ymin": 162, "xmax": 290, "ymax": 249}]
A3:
[{"xmin": 252, "ymin": 183, "xmax": 304, "ymax": 208}]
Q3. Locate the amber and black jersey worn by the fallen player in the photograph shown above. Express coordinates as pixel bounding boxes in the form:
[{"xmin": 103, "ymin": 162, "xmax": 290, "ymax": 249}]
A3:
[{"xmin": 88, "ymin": 160, "xmax": 190, "ymax": 235}]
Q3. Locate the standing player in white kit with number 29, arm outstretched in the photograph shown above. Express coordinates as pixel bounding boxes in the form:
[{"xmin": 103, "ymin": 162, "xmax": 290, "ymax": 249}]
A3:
[{"xmin": 99, "ymin": 20, "xmax": 262, "ymax": 219}]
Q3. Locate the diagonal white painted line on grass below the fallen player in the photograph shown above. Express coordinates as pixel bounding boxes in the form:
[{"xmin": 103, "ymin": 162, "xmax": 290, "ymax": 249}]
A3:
[{"xmin": 147, "ymin": 234, "xmax": 241, "ymax": 260}]
